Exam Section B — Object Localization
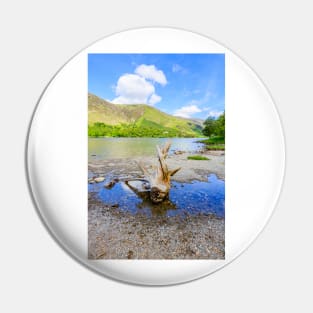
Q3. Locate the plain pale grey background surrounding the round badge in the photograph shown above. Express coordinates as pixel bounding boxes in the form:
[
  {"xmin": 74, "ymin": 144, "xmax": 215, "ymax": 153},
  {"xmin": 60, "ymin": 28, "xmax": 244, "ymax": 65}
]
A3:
[{"xmin": 0, "ymin": 0, "xmax": 313, "ymax": 312}]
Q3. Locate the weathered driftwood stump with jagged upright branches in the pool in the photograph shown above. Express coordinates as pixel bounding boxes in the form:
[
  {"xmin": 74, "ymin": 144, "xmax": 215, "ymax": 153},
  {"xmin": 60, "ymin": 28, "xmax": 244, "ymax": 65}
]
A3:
[{"xmin": 133, "ymin": 142, "xmax": 180, "ymax": 203}]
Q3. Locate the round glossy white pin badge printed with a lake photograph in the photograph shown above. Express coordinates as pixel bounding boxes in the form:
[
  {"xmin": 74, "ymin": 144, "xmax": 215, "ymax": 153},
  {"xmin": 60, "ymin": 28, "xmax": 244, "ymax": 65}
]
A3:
[{"xmin": 27, "ymin": 28, "xmax": 285, "ymax": 285}]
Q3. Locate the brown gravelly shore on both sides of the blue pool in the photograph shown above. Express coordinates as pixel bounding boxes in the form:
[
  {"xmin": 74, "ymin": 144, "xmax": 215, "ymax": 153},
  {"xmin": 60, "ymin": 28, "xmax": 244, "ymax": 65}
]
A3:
[{"xmin": 88, "ymin": 151, "xmax": 225, "ymax": 259}]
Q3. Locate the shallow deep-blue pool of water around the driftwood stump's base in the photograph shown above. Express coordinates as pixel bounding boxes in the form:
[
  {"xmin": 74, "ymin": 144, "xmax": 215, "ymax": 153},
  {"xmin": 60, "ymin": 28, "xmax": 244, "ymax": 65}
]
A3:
[{"xmin": 88, "ymin": 174, "xmax": 225, "ymax": 217}]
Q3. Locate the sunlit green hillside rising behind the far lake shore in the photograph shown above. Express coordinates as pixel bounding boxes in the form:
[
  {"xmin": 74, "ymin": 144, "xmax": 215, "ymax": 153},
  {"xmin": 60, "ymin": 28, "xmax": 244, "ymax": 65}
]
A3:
[{"xmin": 88, "ymin": 94, "xmax": 203, "ymax": 137}]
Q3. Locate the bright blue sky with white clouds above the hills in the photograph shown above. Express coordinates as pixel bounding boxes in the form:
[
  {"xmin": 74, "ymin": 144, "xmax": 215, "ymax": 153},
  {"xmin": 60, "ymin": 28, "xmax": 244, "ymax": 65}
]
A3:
[{"xmin": 88, "ymin": 54, "xmax": 225, "ymax": 119}]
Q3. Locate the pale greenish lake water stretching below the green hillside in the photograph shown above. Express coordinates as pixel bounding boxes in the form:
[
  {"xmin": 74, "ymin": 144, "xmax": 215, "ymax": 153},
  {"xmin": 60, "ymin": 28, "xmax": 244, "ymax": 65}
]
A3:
[{"xmin": 88, "ymin": 138, "xmax": 203, "ymax": 160}]
